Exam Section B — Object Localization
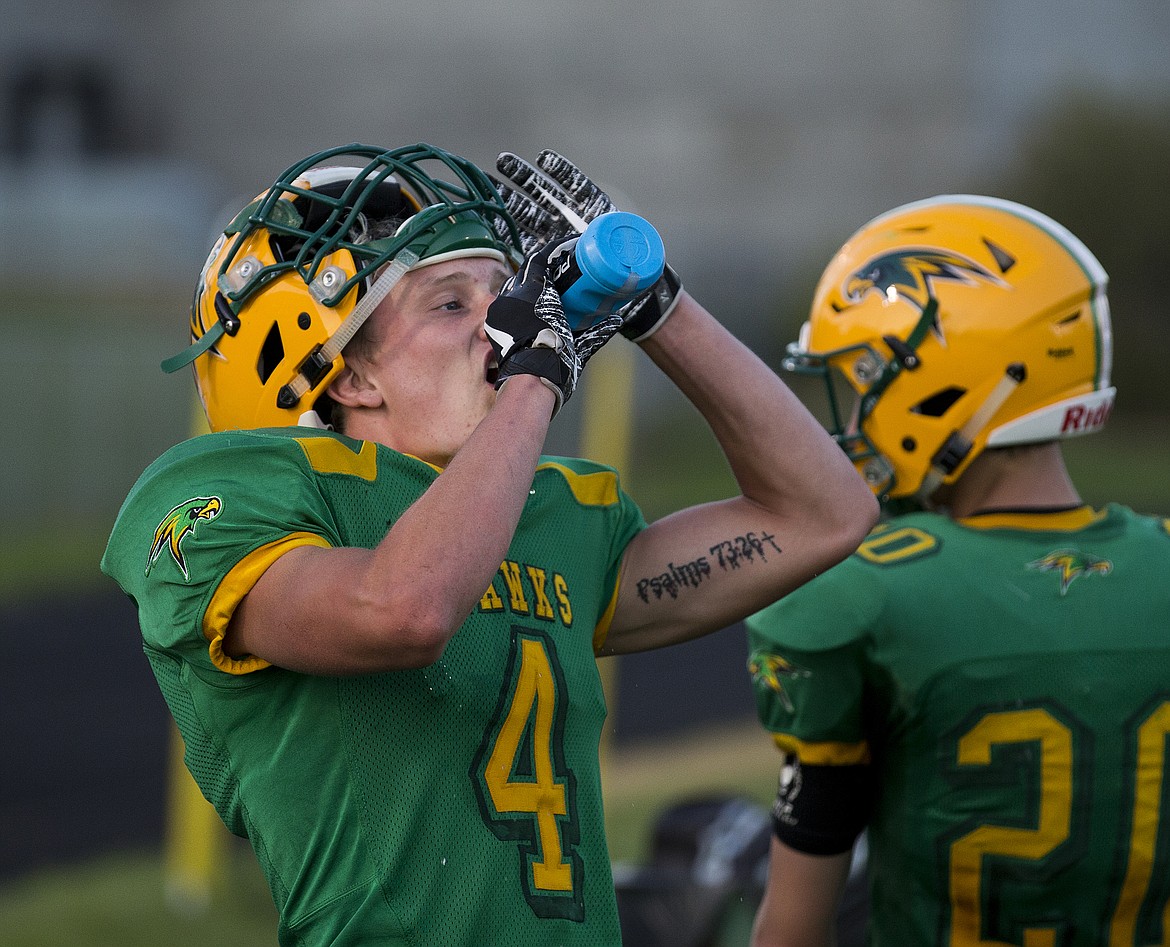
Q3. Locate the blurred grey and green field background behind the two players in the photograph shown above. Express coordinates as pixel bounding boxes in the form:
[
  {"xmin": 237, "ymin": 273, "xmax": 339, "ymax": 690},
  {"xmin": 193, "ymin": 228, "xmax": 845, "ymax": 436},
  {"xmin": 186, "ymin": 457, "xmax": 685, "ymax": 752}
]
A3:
[{"xmin": 0, "ymin": 0, "xmax": 1170, "ymax": 943}]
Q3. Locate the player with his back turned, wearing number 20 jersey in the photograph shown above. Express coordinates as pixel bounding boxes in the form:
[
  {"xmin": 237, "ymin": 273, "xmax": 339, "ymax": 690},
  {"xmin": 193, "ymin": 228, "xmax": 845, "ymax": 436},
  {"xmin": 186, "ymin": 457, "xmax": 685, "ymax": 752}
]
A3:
[{"xmin": 749, "ymin": 195, "xmax": 1170, "ymax": 947}]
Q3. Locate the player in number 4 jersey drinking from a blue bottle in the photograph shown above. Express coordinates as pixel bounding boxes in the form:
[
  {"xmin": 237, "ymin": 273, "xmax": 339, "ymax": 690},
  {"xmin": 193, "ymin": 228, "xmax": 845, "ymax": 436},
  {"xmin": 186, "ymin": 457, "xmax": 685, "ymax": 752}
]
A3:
[{"xmin": 103, "ymin": 145, "xmax": 876, "ymax": 947}]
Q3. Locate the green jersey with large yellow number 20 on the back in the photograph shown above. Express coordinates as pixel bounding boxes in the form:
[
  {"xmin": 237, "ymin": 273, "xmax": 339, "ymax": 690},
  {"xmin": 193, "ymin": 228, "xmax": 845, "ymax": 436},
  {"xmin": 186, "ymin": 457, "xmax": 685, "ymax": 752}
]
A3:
[{"xmin": 748, "ymin": 506, "xmax": 1170, "ymax": 947}]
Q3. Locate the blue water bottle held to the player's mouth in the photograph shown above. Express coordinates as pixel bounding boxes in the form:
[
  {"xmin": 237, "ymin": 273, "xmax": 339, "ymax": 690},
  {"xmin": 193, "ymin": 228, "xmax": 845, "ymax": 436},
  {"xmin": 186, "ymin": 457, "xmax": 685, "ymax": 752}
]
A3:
[{"xmin": 551, "ymin": 211, "xmax": 666, "ymax": 331}]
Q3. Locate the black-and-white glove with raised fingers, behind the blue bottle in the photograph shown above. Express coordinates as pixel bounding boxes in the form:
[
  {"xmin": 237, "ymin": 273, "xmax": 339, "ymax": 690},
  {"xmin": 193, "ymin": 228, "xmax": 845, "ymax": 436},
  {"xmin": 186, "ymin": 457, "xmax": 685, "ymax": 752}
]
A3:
[{"xmin": 496, "ymin": 149, "xmax": 682, "ymax": 342}]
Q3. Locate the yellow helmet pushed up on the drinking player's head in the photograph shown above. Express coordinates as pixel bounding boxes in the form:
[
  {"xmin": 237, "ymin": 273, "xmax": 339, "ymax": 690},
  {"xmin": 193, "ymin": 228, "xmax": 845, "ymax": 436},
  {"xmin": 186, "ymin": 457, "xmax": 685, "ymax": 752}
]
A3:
[{"xmin": 163, "ymin": 144, "xmax": 523, "ymax": 431}]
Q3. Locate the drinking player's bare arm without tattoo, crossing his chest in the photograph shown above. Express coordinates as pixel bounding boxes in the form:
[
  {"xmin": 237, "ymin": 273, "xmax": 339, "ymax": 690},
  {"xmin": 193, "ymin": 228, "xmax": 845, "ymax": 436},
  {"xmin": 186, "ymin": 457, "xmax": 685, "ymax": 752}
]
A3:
[{"xmin": 228, "ymin": 376, "xmax": 553, "ymax": 674}]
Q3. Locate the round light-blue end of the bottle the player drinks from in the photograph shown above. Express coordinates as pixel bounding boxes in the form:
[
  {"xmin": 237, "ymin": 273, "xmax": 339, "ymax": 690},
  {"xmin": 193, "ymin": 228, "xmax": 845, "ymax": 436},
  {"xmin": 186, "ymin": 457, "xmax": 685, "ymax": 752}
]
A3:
[{"xmin": 577, "ymin": 211, "xmax": 666, "ymax": 296}]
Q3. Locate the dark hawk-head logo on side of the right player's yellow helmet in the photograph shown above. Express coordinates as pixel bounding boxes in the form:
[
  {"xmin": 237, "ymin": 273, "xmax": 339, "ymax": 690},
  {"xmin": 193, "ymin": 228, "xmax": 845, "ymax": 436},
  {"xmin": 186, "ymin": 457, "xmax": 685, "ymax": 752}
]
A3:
[{"xmin": 841, "ymin": 247, "xmax": 1006, "ymax": 342}]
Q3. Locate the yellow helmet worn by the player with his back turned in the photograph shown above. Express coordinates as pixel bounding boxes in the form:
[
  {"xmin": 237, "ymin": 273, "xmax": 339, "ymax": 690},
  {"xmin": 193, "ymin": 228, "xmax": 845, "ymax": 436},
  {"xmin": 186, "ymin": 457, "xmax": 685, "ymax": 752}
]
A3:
[{"xmin": 784, "ymin": 194, "xmax": 1114, "ymax": 502}]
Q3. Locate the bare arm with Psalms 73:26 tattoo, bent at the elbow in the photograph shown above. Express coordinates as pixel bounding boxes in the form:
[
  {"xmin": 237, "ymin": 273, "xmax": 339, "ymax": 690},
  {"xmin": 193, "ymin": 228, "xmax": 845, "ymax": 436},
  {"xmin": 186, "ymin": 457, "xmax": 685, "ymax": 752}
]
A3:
[{"xmin": 604, "ymin": 293, "xmax": 878, "ymax": 653}]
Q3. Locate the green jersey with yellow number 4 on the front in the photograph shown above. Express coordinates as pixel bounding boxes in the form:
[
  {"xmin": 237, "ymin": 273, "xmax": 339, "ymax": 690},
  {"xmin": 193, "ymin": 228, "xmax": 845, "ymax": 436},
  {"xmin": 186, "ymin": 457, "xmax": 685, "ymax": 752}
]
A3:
[{"xmin": 102, "ymin": 428, "xmax": 645, "ymax": 947}]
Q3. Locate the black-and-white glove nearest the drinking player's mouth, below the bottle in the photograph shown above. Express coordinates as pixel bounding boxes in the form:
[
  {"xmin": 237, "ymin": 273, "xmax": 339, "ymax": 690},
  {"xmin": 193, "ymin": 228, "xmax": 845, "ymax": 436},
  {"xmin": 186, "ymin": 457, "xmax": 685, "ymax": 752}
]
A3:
[{"xmin": 484, "ymin": 238, "xmax": 622, "ymax": 417}]
